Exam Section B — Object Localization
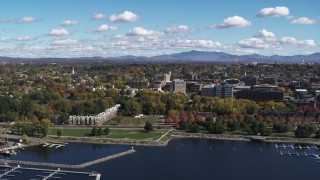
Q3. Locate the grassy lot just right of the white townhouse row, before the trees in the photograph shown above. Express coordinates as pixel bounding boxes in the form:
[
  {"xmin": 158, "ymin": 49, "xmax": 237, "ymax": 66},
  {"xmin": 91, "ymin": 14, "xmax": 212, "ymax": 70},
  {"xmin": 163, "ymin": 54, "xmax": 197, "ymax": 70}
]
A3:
[{"xmin": 103, "ymin": 116, "xmax": 161, "ymax": 125}]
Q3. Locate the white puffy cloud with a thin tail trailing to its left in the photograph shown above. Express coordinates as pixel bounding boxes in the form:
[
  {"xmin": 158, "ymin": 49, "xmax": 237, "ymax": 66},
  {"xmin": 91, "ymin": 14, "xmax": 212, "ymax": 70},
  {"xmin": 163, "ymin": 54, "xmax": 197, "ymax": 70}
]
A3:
[{"xmin": 208, "ymin": 16, "xmax": 251, "ymax": 29}]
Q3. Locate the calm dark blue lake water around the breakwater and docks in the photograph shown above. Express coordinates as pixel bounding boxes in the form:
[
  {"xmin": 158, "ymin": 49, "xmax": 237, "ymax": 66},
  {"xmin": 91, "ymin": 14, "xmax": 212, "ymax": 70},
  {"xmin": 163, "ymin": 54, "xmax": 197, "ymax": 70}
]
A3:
[{"xmin": 0, "ymin": 139, "xmax": 320, "ymax": 180}]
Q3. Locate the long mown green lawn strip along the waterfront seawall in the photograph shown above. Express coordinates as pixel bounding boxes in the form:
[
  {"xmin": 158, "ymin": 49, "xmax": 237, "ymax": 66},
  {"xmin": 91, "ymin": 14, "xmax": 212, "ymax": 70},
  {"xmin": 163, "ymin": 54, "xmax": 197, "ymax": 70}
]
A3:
[{"xmin": 49, "ymin": 129, "xmax": 167, "ymax": 140}]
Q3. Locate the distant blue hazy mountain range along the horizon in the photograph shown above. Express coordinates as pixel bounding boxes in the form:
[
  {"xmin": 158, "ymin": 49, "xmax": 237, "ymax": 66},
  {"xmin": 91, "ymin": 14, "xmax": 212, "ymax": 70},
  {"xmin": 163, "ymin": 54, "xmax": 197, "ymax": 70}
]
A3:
[{"xmin": 0, "ymin": 50, "xmax": 320, "ymax": 63}]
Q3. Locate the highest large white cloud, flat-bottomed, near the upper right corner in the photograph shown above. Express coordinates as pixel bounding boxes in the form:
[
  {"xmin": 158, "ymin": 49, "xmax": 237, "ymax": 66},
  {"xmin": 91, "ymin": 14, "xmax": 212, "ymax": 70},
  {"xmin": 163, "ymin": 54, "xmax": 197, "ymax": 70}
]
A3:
[{"xmin": 257, "ymin": 6, "xmax": 290, "ymax": 17}]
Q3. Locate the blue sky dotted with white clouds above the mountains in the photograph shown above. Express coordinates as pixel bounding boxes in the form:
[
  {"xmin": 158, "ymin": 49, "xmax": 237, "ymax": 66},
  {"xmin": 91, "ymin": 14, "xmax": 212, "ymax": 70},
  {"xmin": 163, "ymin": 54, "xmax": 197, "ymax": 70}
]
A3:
[{"xmin": 0, "ymin": 0, "xmax": 320, "ymax": 58}]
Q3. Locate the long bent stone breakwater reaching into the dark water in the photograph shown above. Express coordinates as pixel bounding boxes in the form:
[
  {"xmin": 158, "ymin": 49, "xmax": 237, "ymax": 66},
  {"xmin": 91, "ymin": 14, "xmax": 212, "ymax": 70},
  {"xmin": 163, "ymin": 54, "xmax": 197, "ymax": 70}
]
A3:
[{"xmin": 1, "ymin": 148, "xmax": 136, "ymax": 169}]
